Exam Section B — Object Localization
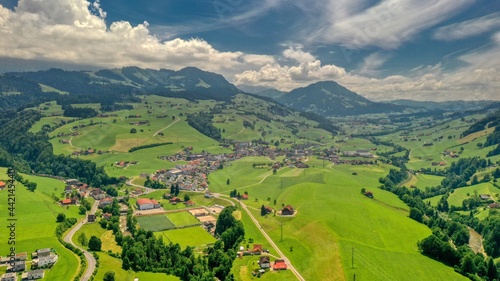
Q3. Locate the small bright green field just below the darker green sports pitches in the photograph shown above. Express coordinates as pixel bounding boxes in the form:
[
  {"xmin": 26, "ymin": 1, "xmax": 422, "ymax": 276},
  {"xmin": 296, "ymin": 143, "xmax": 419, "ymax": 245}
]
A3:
[{"xmin": 155, "ymin": 226, "xmax": 215, "ymax": 248}]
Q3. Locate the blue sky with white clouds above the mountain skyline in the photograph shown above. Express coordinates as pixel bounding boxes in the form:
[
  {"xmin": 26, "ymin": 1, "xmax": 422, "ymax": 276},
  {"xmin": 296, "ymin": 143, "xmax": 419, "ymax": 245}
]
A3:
[{"xmin": 0, "ymin": 0, "xmax": 500, "ymax": 101}]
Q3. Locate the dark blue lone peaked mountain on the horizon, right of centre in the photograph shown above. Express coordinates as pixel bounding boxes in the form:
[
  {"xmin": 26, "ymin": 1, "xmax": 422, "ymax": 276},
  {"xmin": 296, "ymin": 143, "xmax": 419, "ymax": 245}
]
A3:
[{"xmin": 277, "ymin": 81, "xmax": 406, "ymax": 116}]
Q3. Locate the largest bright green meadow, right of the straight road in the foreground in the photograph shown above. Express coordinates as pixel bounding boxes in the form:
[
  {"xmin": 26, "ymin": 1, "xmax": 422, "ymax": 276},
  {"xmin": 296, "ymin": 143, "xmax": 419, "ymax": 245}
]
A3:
[{"xmin": 209, "ymin": 159, "xmax": 466, "ymax": 280}]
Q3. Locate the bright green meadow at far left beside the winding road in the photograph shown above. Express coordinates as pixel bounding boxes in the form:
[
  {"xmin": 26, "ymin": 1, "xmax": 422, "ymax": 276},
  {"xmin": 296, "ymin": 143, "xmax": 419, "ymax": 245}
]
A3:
[{"xmin": 0, "ymin": 168, "xmax": 82, "ymax": 281}]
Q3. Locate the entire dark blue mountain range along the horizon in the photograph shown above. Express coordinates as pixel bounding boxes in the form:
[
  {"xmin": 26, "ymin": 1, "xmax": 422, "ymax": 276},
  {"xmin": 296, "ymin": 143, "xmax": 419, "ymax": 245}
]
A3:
[{"xmin": 0, "ymin": 67, "xmax": 489, "ymax": 117}]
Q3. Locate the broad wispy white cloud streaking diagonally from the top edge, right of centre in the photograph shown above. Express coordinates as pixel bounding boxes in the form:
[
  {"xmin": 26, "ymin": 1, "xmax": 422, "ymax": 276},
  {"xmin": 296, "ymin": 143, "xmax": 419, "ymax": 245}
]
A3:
[{"xmin": 312, "ymin": 0, "xmax": 474, "ymax": 49}]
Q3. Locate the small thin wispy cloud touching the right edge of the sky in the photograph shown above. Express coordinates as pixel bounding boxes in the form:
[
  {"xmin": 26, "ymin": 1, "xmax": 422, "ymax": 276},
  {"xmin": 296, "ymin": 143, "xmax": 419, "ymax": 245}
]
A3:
[{"xmin": 434, "ymin": 12, "xmax": 500, "ymax": 41}]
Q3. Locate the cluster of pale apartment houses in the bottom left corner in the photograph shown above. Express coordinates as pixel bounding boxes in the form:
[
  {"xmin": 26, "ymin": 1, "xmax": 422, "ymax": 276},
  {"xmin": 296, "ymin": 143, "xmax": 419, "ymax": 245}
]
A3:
[{"xmin": 0, "ymin": 248, "xmax": 59, "ymax": 281}]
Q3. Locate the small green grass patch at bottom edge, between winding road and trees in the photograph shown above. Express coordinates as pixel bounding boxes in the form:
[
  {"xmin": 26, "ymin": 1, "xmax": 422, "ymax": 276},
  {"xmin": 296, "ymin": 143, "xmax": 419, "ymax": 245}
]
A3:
[{"xmin": 94, "ymin": 253, "xmax": 180, "ymax": 281}]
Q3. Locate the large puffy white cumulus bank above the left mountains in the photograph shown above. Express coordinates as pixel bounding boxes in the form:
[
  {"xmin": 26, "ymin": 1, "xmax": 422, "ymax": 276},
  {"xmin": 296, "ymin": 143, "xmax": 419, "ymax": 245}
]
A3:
[{"xmin": 0, "ymin": 0, "xmax": 273, "ymax": 73}]
